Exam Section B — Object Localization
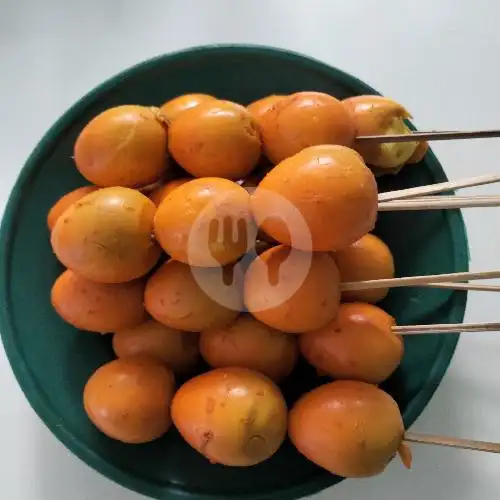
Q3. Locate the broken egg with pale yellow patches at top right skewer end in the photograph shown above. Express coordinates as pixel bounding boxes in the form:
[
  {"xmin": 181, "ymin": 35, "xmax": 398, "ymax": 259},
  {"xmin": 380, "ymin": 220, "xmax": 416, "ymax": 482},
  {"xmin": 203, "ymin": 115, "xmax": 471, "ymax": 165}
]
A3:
[{"xmin": 342, "ymin": 95, "xmax": 418, "ymax": 171}]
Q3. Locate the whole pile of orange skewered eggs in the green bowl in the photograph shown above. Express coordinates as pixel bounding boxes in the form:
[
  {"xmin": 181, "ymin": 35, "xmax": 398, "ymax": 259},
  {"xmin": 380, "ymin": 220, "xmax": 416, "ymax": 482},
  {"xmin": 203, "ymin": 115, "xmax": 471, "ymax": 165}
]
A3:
[{"xmin": 48, "ymin": 92, "xmax": 427, "ymax": 477}]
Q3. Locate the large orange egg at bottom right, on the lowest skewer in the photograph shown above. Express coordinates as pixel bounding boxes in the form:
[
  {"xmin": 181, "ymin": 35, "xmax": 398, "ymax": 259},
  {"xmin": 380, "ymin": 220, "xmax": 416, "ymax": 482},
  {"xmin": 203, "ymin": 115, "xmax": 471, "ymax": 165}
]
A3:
[{"xmin": 288, "ymin": 381, "xmax": 405, "ymax": 478}]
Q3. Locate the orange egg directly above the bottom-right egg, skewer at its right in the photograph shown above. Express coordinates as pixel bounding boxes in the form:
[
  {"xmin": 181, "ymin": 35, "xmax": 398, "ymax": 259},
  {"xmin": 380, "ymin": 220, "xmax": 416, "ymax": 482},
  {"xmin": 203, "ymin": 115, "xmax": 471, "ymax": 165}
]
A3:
[{"xmin": 299, "ymin": 302, "xmax": 404, "ymax": 384}]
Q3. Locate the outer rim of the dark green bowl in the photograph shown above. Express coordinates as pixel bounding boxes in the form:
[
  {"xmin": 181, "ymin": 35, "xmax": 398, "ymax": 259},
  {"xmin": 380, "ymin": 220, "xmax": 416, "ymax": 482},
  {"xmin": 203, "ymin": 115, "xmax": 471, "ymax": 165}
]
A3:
[{"xmin": 0, "ymin": 43, "xmax": 469, "ymax": 500}]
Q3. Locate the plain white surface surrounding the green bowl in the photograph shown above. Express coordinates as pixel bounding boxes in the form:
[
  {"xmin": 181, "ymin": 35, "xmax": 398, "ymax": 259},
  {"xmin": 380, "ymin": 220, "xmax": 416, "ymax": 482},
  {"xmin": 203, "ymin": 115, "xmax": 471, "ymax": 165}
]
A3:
[{"xmin": 0, "ymin": 0, "xmax": 500, "ymax": 500}]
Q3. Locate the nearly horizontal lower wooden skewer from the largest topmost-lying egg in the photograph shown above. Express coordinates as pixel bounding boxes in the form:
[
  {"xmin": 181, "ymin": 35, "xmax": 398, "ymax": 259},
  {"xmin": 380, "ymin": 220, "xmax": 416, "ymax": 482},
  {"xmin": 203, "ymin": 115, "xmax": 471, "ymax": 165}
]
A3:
[{"xmin": 378, "ymin": 196, "xmax": 500, "ymax": 212}]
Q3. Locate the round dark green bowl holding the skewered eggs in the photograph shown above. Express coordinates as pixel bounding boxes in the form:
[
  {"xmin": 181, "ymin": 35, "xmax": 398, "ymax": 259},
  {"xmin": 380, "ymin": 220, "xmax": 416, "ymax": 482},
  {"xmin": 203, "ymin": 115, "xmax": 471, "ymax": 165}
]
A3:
[{"xmin": 0, "ymin": 45, "xmax": 468, "ymax": 500}]
